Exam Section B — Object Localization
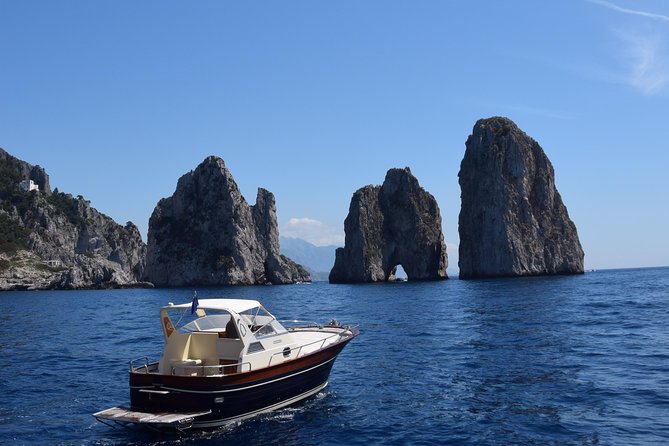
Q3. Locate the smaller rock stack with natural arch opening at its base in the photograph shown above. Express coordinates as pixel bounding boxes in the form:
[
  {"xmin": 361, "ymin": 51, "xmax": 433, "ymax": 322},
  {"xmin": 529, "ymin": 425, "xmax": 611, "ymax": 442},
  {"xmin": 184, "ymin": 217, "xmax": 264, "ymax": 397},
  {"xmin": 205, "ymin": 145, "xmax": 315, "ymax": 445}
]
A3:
[{"xmin": 329, "ymin": 167, "xmax": 448, "ymax": 283}]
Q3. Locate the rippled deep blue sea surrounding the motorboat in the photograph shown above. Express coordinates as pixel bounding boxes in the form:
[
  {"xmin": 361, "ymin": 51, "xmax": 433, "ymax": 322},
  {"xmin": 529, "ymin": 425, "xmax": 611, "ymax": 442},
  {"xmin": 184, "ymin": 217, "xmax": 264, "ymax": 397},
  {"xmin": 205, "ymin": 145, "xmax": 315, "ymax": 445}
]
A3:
[{"xmin": 0, "ymin": 268, "xmax": 669, "ymax": 446}]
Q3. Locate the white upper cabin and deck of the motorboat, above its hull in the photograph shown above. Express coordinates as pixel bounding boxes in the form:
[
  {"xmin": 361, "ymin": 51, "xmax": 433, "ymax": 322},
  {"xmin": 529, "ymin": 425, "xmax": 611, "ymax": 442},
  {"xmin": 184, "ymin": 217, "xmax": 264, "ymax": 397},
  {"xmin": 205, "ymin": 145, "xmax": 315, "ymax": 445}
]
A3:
[{"xmin": 157, "ymin": 299, "xmax": 343, "ymax": 376}]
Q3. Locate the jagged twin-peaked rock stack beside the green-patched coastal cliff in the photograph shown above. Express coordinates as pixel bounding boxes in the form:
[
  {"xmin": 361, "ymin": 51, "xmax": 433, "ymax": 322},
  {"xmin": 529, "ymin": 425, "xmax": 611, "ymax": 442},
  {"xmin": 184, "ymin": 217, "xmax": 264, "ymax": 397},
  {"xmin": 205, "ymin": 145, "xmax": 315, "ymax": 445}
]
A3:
[{"xmin": 145, "ymin": 156, "xmax": 310, "ymax": 286}]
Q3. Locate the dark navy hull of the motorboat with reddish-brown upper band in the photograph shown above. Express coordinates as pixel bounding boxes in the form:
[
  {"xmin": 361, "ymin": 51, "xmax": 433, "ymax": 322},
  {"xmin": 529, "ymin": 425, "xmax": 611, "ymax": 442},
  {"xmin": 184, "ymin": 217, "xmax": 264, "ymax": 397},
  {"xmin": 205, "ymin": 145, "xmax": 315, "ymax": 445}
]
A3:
[{"xmin": 129, "ymin": 337, "xmax": 352, "ymax": 428}]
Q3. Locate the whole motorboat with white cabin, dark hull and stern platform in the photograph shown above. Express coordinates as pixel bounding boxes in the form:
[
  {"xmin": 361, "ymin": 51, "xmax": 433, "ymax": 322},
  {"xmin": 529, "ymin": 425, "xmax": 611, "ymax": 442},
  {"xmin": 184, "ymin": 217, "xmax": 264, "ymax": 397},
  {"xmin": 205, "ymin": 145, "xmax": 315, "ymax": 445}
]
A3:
[{"xmin": 93, "ymin": 295, "xmax": 359, "ymax": 431}]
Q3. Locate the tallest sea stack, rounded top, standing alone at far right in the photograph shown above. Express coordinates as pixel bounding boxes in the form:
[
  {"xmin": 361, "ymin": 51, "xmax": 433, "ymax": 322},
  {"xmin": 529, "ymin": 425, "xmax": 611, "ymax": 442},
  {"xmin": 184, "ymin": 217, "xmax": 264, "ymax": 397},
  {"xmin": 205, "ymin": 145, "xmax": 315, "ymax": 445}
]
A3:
[{"xmin": 458, "ymin": 117, "xmax": 584, "ymax": 279}]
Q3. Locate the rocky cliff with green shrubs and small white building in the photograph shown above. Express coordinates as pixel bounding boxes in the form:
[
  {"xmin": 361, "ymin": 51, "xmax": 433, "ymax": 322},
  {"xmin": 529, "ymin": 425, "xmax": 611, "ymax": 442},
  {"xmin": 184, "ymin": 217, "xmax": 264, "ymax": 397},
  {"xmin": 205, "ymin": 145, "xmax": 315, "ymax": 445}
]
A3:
[{"xmin": 0, "ymin": 149, "xmax": 146, "ymax": 290}]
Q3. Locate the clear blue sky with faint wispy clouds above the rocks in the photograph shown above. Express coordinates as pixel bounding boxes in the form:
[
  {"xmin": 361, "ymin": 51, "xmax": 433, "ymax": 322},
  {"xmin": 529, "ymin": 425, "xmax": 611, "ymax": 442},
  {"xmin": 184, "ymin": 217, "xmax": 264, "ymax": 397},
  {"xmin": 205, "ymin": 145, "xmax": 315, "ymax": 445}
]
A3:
[{"xmin": 0, "ymin": 0, "xmax": 669, "ymax": 273}]
